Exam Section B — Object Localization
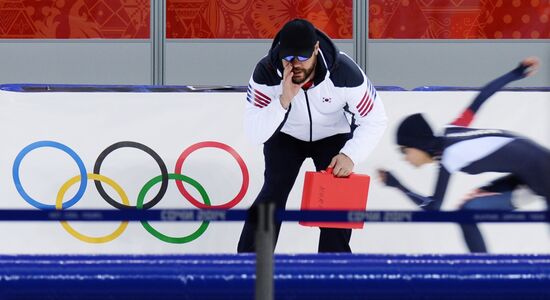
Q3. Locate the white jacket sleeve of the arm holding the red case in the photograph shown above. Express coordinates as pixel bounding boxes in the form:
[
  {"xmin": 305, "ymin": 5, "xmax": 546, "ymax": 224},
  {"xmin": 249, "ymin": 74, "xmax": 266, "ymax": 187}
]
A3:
[{"xmin": 340, "ymin": 76, "xmax": 387, "ymax": 165}]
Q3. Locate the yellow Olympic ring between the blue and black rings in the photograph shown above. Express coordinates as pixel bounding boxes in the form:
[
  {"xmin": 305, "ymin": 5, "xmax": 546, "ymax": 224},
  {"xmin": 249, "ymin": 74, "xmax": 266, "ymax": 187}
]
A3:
[{"xmin": 55, "ymin": 173, "xmax": 130, "ymax": 244}]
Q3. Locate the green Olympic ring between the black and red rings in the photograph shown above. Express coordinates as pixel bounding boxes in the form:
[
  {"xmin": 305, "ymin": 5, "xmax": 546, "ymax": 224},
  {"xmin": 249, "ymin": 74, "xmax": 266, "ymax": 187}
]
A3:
[{"xmin": 136, "ymin": 173, "xmax": 210, "ymax": 244}]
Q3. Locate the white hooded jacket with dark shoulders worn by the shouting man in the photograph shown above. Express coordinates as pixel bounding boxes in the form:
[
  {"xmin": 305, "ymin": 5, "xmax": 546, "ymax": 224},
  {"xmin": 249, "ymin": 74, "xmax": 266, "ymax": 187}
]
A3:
[{"xmin": 244, "ymin": 31, "xmax": 386, "ymax": 164}]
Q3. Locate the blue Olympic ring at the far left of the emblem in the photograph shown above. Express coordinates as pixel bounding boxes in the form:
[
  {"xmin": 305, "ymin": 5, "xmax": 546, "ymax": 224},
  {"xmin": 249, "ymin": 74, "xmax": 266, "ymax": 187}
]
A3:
[{"xmin": 13, "ymin": 141, "xmax": 88, "ymax": 210}]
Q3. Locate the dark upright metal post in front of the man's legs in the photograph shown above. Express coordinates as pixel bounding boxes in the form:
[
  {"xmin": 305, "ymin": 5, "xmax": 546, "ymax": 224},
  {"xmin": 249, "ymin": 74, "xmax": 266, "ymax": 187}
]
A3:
[{"xmin": 255, "ymin": 203, "xmax": 275, "ymax": 300}]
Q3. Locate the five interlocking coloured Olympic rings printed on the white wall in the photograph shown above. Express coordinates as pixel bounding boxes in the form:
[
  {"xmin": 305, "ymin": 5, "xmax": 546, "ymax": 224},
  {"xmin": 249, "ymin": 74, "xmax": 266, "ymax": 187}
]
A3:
[{"xmin": 13, "ymin": 141, "xmax": 249, "ymax": 244}]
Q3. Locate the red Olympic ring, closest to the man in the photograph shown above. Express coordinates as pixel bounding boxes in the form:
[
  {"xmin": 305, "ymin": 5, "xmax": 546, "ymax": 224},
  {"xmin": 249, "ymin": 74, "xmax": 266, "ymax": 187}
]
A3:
[{"xmin": 174, "ymin": 141, "xmax": 249, "ymax": 209}]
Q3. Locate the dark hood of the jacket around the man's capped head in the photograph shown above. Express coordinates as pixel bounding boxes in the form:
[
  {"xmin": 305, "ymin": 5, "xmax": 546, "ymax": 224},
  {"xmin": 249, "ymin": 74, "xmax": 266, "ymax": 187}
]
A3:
[{"xmin": 267, "ymin": 29, "xmax": 339, "ymax": 84}]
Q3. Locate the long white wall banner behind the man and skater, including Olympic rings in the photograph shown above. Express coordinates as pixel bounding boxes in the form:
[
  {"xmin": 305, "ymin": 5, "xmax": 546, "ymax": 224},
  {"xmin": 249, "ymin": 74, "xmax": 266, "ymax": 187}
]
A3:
[{"xmin": 0, "ymin": 91, "xmax": 550, "ymax": 254}]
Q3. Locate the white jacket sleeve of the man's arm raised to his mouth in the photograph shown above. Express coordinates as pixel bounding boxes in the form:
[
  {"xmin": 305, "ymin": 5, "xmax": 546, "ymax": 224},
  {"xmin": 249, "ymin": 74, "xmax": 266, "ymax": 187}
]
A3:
[{"xmin": 244, "ymin": 78, "xmax": 287, "ymax": 144}]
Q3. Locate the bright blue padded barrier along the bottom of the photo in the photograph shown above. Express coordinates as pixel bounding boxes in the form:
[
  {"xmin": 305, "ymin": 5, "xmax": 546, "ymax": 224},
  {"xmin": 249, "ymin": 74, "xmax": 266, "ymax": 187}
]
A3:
[{"xmin": 0, "ymin": 254, "xmax": 550, "ymax": 300}]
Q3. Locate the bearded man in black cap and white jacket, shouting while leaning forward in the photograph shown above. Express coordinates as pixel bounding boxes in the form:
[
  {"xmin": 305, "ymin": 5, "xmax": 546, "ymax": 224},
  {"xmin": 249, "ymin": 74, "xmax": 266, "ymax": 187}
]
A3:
[{"xmin": 237, "ymin": 19, "xmax": 386, "ymax": 252}]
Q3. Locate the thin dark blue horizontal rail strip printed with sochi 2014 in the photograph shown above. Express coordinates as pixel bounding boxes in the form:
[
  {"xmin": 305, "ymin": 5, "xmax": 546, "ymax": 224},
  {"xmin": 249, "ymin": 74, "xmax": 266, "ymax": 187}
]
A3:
[{"xmin": 0, "ymin": 209, "xmax": 550, "ymax": 223}]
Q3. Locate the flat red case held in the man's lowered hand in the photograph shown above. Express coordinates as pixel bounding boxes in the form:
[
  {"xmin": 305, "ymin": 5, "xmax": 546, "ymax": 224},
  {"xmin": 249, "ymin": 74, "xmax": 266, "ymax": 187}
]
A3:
[{"xmin": 299, "ymin": 169, "xmax": 370, "ymax": 228}]
